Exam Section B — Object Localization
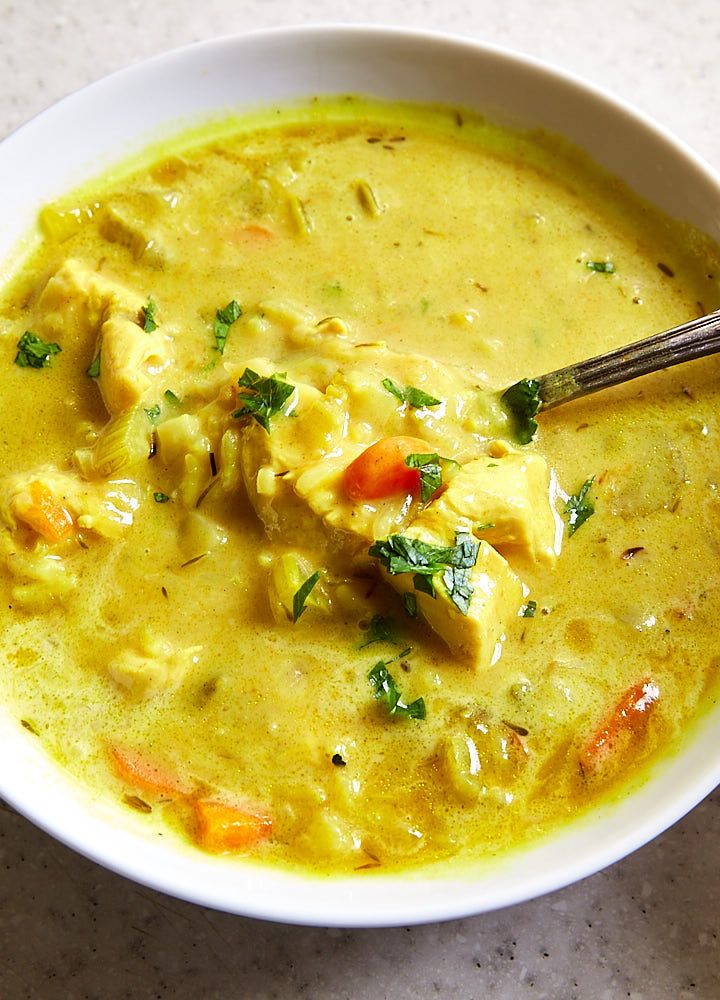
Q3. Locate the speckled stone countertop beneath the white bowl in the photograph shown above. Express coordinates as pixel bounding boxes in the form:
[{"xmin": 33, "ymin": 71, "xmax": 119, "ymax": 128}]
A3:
[{"xmin": 0, "ymin": 0, "xmax": 720, "ymax": 1000}]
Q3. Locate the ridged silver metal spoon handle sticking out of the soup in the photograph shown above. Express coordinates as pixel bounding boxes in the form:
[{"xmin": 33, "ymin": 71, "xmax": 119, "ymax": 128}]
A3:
[{"xmin": 537, "ymin": 311, "xmax": 720, "ymax": 410}]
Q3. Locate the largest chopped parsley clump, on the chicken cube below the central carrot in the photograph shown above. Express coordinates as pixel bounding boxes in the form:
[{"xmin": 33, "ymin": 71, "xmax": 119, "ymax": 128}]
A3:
[{"xmin": 368, "ymin": 531, "xmax": 480, "ymax": 615}]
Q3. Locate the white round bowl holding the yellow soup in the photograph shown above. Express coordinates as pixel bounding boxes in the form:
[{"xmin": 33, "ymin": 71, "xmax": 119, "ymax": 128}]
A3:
[{"xmin": 0, "ymin": 26, "xmax": 720, "ymax": 927}]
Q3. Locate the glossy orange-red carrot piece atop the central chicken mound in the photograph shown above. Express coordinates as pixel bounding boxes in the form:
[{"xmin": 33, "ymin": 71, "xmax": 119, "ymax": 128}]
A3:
[{"xmin": 343, "ymin": 437, "xmax": 432, "ymax": 500}]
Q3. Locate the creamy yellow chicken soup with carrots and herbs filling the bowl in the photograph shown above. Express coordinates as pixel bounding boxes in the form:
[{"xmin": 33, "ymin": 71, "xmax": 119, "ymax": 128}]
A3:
[{"xmin": 0, "ymin": 98, "xmax": 720, "ymax": 872}]
